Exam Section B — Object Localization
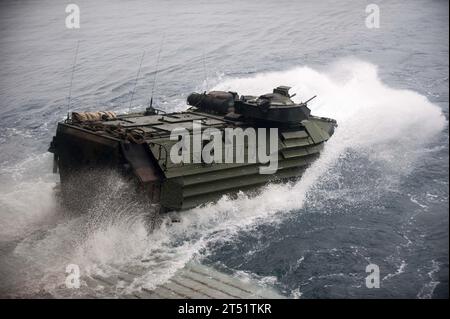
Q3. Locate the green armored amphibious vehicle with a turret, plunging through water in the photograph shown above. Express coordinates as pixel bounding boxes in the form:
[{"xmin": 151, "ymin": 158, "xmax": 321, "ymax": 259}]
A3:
[{"xmin": 49, "ymin": 86, "xmax": 336, "ymax": 211}]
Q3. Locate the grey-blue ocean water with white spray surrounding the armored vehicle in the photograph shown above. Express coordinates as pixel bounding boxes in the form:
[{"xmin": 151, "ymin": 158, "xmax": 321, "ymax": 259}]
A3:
[{"xmin": 0, "ymin": 0, "xmax": 449, "ymax": 298}]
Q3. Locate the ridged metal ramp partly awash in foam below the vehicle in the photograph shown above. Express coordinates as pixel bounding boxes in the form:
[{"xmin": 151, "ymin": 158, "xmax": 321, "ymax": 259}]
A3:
[{"xmin": 54, "ymin": 262, "xmax": 286, "ymax": 299}]
